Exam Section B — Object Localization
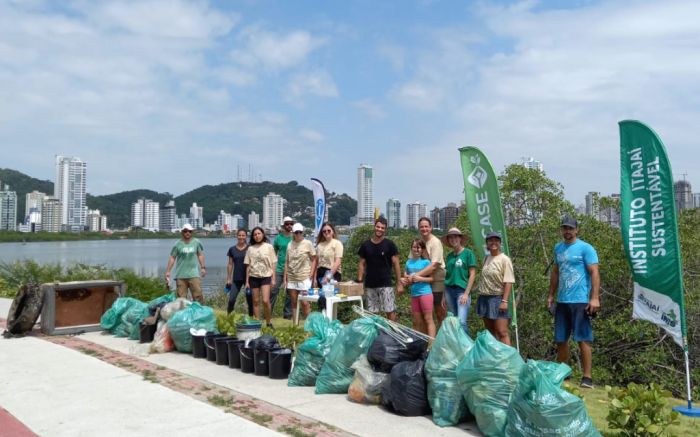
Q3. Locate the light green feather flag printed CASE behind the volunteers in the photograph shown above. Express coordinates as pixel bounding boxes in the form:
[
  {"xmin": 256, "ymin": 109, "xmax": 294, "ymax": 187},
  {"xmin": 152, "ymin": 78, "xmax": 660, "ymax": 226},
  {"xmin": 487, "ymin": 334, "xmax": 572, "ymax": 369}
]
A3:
[{"xmin": 459, "ymin": 147, "xmax": 518, "ymax": 325}]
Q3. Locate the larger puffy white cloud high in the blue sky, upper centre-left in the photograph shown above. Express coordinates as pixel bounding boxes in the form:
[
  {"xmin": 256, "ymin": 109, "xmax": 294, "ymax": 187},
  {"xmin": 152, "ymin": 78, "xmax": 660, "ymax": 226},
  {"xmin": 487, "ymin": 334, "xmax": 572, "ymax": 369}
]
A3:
[{"xmin": 232, "ymin": 27, "xmax": 323, "ymax": 70}]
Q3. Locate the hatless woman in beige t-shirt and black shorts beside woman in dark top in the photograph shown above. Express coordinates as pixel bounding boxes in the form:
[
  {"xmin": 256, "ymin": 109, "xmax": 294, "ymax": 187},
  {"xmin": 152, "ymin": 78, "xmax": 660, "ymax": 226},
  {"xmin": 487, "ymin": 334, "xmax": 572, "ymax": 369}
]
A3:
[{"xmin": 243, "ymin": 227, "xmax": 277, "ymax": 327}]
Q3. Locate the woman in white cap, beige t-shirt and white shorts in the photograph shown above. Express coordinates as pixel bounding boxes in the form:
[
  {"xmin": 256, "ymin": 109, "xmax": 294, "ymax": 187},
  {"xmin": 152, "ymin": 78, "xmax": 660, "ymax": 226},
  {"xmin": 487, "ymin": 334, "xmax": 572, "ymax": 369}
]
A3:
[{"xmin": 284, "ymin": 223, "xmax": 316, "ymax": 317}]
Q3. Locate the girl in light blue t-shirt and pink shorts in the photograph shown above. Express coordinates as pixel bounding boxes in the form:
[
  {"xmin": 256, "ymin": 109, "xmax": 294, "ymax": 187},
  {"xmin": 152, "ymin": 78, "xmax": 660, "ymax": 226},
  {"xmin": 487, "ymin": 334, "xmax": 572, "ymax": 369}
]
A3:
[{"xmin": 401, "ymin": 238, "xmax": 435, "ymax": 337}]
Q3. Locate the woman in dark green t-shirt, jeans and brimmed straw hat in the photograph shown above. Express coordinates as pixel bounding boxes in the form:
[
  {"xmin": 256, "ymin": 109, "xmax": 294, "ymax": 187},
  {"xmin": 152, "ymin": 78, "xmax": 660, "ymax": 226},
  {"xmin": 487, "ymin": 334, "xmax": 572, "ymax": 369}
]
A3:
[{"xmin": 442, "ymin": 228, "xmax": 476, "ymax": 334}]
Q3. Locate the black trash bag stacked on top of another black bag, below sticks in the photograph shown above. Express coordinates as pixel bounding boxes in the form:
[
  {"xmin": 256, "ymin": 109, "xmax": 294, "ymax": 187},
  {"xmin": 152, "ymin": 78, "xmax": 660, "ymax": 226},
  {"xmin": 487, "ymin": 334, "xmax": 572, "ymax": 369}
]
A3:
[{"xmin": 367, "ymin": 330, "xmax": 428, "ymax": 373}]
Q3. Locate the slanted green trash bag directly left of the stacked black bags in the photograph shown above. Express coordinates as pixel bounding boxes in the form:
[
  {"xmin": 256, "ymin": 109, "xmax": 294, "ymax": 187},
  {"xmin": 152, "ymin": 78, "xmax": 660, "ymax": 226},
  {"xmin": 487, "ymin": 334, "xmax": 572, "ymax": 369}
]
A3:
[{"xmin": 316, "ymin": 317, "xmax": 383, "ymax": 394}]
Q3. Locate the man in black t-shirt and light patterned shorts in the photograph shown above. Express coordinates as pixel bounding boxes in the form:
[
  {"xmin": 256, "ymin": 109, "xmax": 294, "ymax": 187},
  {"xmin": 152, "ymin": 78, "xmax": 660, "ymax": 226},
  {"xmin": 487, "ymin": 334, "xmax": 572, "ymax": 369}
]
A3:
[{"xmin": 357, "ymin": 216, "xmax": 403, "ymax": 321}]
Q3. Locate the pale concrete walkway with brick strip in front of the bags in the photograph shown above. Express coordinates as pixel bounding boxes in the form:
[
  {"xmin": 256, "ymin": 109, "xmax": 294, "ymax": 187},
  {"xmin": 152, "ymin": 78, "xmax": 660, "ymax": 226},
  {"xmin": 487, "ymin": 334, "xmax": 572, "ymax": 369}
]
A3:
[{"xmin": 0, "ymin": 299, "xmax": 480, "ymax": 436}]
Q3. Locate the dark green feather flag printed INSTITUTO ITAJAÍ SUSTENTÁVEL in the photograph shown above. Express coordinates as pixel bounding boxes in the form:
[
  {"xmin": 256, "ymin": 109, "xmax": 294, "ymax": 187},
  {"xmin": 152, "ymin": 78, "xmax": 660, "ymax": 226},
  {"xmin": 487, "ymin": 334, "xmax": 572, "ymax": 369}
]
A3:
[{"xmin": 620, "ymin": 120, "xmax": 687, "ymax": 347}]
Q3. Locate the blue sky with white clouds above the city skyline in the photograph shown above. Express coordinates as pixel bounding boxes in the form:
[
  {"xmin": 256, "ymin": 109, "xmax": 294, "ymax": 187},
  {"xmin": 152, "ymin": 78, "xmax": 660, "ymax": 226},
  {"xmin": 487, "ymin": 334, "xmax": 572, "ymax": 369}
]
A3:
[{"xmin": 0, "ymin": 0, "xmax": 700, "ymax": 216}]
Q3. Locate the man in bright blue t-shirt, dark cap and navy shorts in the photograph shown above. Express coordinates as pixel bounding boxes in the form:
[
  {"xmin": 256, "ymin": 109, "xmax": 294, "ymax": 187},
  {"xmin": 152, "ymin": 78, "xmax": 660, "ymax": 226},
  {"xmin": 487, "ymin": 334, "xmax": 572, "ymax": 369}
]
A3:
[{"xmin": 547, "ymin": 216, "xmax": 600, "ymax": 388}]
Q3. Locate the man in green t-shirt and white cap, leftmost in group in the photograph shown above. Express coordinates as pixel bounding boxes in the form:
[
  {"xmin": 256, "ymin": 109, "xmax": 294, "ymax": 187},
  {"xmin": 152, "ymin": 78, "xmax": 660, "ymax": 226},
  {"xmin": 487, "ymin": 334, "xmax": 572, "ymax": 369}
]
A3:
[{"xmin": 165, "ymin": 223, "xmax": 207, "ymax": 304}]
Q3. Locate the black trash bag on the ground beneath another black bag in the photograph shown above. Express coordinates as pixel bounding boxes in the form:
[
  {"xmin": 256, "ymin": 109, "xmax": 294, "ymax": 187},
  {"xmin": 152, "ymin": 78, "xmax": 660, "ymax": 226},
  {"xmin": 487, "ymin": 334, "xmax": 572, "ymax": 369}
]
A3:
[{"xmin": 382, "ymin": 359, "xmax": 430, "ymax": 416}]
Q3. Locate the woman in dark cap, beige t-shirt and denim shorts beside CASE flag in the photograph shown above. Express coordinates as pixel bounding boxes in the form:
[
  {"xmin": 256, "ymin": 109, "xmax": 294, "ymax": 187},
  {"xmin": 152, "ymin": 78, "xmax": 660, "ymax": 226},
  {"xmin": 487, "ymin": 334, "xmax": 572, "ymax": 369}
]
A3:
[{"xmin": 476, "ymin": 232, "xmax": 515, "ymax": 346}]
